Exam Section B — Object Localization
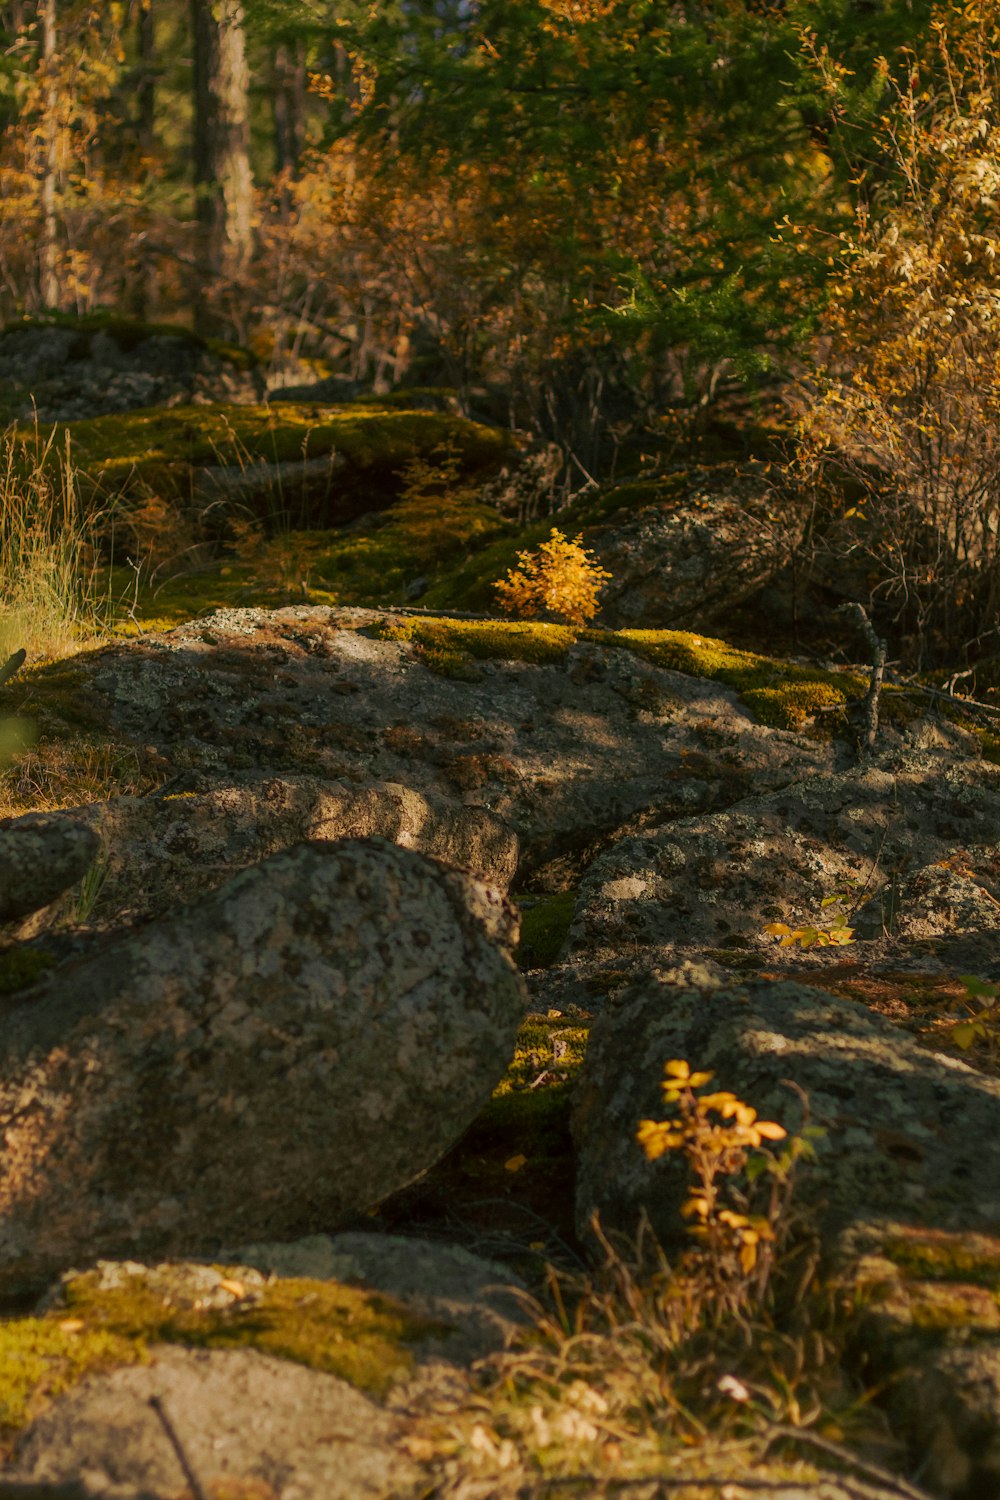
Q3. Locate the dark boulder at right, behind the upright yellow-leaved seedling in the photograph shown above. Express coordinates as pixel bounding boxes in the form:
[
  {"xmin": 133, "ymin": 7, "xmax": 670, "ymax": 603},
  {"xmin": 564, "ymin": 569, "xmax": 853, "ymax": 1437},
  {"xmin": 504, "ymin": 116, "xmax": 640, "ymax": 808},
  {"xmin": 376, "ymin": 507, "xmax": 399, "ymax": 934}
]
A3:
[{"xmin": 574, "ymin": 978, "xmax": 1000, "ymax": 1239}]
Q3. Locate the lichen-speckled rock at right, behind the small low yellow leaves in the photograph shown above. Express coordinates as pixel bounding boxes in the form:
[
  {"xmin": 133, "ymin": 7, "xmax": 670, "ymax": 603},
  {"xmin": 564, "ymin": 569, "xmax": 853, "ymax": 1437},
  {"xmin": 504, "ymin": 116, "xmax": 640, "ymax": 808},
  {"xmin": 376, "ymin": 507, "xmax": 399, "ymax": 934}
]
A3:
[{"xmin": 568, "ymin": 752, "xmax": 1000, "ymax": 956}]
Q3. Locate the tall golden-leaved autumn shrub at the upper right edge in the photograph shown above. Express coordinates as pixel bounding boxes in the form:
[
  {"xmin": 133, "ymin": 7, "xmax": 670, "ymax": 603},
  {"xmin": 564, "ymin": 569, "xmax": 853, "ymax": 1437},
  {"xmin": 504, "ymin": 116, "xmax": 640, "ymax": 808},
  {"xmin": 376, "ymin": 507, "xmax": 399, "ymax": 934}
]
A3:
[{"xmin": 795, "ymin": 3, "xmax": 1000, "ymax": 663}]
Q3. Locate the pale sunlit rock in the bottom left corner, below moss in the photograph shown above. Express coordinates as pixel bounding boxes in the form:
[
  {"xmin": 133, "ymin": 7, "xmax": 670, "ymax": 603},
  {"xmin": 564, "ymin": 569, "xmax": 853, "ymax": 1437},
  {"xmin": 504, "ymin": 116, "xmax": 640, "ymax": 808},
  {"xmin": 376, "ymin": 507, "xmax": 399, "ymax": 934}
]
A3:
[{"xmin": 0, "ymin": 1347, "xmax": 420, "ymax": 1500}]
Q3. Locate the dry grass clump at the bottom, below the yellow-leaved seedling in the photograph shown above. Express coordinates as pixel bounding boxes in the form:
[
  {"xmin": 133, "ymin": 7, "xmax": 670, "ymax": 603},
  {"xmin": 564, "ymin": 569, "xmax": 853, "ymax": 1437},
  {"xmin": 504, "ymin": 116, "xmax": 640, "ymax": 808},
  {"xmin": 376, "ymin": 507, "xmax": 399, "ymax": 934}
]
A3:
[{"xmin": 420, "ymin": 1218, "xmax": 919, "ymax": 1500}]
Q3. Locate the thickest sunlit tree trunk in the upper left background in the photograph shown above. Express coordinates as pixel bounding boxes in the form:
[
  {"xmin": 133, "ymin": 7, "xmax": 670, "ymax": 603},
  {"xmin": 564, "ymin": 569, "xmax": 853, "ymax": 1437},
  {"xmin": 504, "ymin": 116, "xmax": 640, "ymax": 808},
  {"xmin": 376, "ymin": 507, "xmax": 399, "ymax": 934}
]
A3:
[{"xmin": 190, "ymin": 0, "xmax": 253, "ymax": 325}]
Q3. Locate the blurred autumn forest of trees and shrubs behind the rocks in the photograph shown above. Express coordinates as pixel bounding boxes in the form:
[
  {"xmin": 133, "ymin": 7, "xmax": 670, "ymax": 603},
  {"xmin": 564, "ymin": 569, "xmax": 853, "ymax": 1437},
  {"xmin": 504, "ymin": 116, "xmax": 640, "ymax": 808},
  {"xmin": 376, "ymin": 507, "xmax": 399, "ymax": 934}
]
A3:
[{"xmin": 0, "ymin": 0, "xmax": 1000, "ymax": 663}]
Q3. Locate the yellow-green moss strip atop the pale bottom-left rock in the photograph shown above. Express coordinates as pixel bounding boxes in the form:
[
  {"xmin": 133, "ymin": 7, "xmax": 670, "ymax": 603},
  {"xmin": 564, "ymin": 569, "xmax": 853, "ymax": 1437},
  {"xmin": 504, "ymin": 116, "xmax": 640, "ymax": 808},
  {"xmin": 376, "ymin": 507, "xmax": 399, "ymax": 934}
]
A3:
[{"xmin": 63, "ymin": 1268, "xmax": 448, "ymax": 1395}]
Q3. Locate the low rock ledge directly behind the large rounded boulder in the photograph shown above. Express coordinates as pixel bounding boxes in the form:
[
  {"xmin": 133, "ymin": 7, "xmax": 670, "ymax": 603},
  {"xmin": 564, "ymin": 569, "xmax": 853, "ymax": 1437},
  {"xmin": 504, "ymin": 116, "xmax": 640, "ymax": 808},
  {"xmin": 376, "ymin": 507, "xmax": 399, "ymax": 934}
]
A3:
[{"xmin": 47, "ymin": 776, "xmax": 517, "ymax": 926}]
